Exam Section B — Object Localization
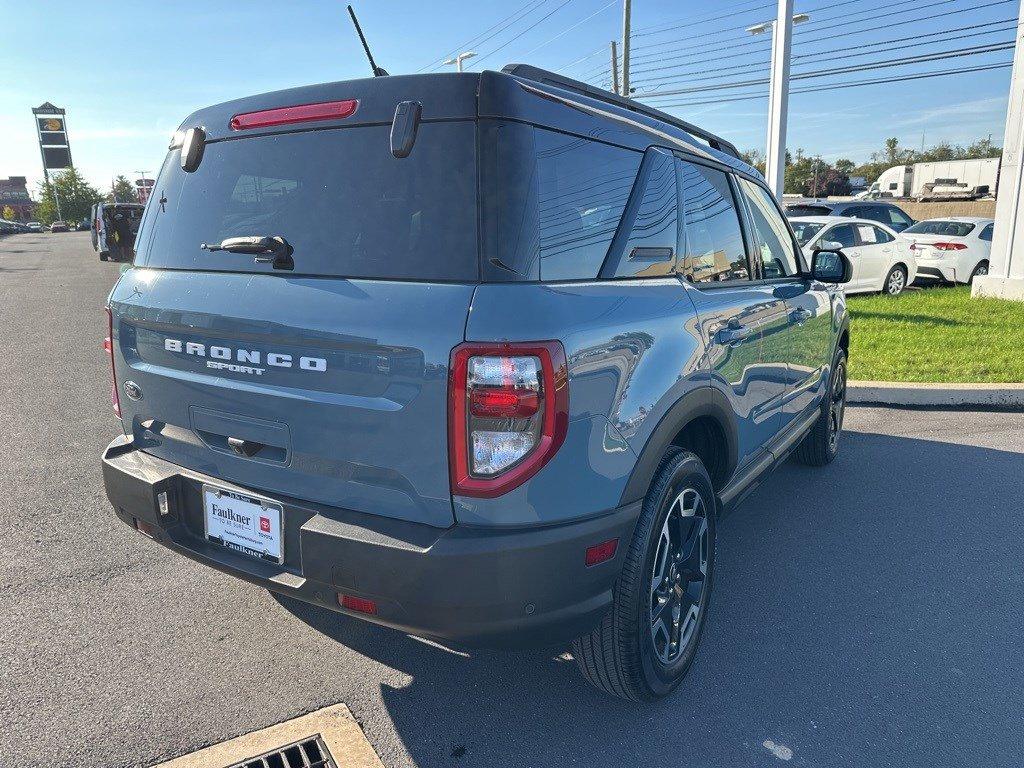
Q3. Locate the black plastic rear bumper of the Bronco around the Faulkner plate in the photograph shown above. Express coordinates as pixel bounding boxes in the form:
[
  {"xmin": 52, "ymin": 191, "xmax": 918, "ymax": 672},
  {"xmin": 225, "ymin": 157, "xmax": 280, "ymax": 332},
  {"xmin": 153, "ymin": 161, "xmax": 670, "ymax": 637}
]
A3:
[{"xmin": 102, "ymin": 437, "xmax": 640, "ymax": 647}]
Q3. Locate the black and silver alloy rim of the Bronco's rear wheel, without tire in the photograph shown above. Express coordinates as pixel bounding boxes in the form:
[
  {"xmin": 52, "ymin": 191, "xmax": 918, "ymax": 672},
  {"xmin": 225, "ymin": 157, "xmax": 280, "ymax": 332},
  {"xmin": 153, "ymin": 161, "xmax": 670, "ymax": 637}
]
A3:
[{"xmin": 650, "ymin": 487, "xmax": 709, "ymax": 666}]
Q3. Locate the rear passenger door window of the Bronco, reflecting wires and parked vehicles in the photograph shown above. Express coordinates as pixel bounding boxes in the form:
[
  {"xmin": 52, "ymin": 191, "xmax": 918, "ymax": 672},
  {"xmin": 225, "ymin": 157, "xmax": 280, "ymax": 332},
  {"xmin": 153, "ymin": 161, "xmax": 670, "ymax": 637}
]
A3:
[{"xmin": 676, "ymin": 160, "xmax": 750, "ymax": 283}]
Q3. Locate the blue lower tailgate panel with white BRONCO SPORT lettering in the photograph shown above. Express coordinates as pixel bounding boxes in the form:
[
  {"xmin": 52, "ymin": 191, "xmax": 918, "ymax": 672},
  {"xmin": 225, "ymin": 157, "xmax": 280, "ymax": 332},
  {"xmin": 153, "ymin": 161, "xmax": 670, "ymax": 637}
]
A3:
[{"xmin": 111, "ymin": 269, "xmax": 473, "ymax": 526}]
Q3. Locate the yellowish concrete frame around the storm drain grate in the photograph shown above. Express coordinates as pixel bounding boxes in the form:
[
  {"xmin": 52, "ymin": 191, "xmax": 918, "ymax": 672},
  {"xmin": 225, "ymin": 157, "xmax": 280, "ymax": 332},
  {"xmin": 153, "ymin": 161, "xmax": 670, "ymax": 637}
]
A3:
[{"xmin": 153, "ymin": 705, "xmax": 384, "ymax": 768}]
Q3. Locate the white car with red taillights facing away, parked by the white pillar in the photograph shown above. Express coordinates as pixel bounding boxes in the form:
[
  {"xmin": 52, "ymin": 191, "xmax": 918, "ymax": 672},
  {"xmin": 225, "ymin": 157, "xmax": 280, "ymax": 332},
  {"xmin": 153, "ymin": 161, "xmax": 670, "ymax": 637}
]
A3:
[{"xmin": 902, "ymin": 216, "xmax": 994, "ymax": 283}]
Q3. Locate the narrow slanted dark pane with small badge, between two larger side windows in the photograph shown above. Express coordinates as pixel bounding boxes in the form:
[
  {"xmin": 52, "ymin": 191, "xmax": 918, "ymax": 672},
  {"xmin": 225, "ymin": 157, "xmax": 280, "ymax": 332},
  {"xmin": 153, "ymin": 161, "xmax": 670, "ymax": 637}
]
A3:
[{"xmin": 606, "ymin": 148, "xmax": 679, "ymax": 278}]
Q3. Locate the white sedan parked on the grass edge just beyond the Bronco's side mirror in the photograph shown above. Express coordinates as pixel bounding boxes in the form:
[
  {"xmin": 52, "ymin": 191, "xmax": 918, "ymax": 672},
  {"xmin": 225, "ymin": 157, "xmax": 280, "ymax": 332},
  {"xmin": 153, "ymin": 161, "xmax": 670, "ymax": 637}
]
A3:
[{"xmin": 790, "ymin": 221, "xmax": 918, "ymax": 296}]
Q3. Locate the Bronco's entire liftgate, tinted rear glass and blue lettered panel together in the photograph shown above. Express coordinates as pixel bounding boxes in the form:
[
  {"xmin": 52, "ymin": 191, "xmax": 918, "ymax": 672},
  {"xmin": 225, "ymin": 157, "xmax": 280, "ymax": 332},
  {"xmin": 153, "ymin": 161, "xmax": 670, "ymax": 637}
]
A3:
[{"xmin": 111, "ymin": 93, "xmax": 479, "ymax": 526}]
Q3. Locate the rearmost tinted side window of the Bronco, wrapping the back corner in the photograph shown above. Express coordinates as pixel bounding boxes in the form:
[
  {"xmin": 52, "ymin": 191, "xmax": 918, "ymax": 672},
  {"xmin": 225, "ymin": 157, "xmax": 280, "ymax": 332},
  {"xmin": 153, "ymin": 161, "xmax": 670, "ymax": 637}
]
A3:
[{"xmin": 480, "ymin": 120, "xmax": 643, "ymax": 281}]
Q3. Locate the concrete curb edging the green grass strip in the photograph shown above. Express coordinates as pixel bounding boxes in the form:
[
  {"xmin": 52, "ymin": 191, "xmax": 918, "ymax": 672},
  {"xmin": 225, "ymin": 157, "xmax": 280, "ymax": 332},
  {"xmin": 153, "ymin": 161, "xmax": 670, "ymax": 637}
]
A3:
[{"xmin": 846, "ymin": 381, "xmax": 1024, "ymax": 410}]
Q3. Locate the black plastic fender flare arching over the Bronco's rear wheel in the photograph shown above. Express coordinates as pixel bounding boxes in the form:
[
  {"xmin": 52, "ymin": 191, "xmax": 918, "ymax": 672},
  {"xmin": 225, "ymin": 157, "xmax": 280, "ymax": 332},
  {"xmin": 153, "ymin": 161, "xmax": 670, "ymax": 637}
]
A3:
[{"xmin": 620, "ymin": 385, "xmax": 739, "ymax": 505}]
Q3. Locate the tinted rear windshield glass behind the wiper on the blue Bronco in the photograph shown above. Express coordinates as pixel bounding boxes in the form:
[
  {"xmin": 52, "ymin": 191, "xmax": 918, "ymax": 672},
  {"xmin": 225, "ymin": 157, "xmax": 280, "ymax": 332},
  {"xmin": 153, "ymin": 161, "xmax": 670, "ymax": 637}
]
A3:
[{"xmin": 135, "ymin": 121, "xmax": 479, "ymax": 282}]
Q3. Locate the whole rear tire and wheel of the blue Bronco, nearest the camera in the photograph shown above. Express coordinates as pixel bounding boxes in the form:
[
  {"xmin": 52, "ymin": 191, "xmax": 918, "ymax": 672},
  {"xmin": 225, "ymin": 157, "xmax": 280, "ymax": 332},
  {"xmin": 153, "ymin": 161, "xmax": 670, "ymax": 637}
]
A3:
[{"xmin": 572, "ymin": 447, "xmax": 718, "ymax": 701}]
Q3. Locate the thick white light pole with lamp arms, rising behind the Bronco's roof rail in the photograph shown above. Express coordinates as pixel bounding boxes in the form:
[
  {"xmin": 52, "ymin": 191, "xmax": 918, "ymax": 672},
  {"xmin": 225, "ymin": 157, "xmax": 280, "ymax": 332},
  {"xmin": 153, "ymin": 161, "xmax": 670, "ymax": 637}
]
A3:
[{"xmin": 746, "ymin": 6, "xmax": 810, "ymax": 200}]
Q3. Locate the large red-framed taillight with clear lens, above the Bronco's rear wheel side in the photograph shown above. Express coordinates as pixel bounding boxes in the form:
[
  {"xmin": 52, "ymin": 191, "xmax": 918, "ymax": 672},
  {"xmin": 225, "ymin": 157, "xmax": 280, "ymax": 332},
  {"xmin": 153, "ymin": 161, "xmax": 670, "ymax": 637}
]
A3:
[{"xmin": 449, "ymin": 341, "xmax": 569, "ymax": 497}]
